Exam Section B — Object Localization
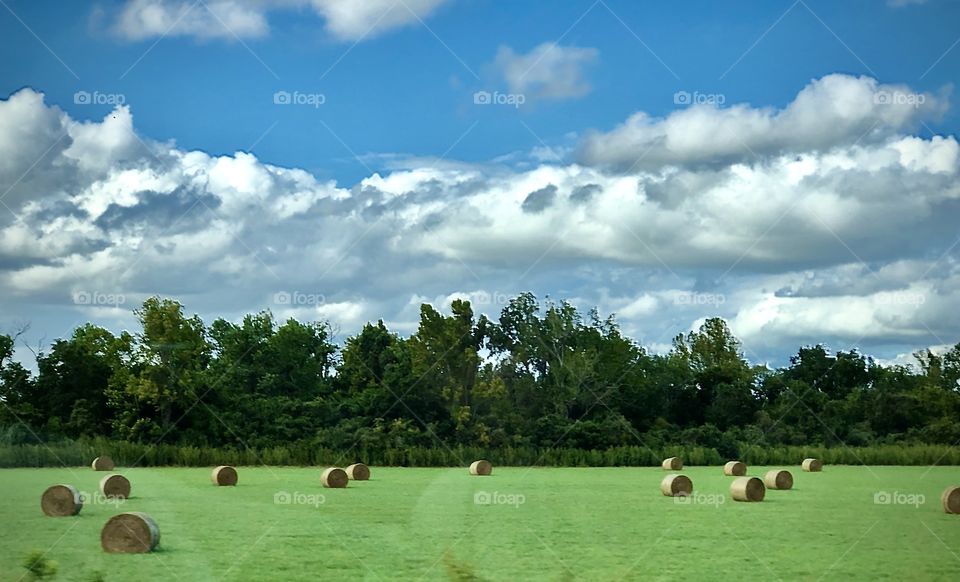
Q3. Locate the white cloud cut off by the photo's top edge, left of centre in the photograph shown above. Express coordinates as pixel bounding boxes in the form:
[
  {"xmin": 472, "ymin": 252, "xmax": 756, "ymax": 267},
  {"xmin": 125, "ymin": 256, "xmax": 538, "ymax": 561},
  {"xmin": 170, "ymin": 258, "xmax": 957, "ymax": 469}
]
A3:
[{"xmin": 114, "ymin": 0, "xmax": 446, "ymax": 41}]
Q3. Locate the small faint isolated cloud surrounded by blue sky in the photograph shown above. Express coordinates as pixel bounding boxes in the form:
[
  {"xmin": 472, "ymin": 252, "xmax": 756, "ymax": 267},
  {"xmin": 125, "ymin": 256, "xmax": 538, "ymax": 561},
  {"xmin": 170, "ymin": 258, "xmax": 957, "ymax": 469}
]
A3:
[{"xmin": 493, "ymin": 42, "xmax": 599, "ymax": 100}]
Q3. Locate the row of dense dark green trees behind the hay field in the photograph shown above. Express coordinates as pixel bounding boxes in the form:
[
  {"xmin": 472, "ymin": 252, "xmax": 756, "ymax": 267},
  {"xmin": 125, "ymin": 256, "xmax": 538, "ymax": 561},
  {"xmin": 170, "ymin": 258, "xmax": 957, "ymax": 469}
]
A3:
[{"xmin": 0, "ymin": 293, "xmax": 960, "ymax": 458}]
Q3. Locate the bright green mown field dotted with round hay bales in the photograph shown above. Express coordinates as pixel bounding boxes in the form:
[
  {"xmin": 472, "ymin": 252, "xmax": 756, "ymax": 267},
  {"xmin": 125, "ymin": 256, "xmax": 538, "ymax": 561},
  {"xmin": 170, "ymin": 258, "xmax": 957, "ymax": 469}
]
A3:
[{"xmin": 0, "ymin": 466, "xmax": 960, "ymax": 581}]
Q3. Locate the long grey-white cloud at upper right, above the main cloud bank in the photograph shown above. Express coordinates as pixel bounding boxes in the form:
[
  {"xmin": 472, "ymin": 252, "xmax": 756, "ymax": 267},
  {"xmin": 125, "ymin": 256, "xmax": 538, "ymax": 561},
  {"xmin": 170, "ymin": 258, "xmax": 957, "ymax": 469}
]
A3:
[{"xmin": 579, "ymin": 74, "xmax": 947, "ymax": 169}]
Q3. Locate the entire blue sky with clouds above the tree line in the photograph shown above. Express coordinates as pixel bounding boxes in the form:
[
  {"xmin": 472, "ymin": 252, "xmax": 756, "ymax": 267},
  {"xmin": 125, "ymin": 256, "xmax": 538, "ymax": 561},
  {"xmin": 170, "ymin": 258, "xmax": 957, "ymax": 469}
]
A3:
[{"xmin": 0, "ymin": 0, "xmax": 960, "ymax": 365}]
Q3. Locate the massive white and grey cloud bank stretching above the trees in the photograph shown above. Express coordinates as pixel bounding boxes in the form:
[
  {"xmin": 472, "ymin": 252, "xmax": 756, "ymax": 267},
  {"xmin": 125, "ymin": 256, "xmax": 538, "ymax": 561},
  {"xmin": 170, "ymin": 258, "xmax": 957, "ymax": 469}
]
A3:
[{"xmin": 0, "ymin": 76, "xmax": 960, "ymax": 360}]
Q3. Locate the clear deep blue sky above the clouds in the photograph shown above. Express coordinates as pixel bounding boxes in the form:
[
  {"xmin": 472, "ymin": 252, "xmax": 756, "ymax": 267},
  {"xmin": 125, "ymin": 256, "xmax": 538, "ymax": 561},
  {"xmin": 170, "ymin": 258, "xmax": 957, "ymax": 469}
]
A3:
[{"xmin": 7, "ymin": 0, "xmax": 960, "ymax": 180}]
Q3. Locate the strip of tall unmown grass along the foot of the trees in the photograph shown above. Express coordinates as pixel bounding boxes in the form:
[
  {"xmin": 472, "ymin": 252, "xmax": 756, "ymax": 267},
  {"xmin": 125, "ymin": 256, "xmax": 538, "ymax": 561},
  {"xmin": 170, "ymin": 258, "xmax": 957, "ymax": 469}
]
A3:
[{"xmin": 0, "ymin": 439, "xmax": 960, "ymax": 467}]
